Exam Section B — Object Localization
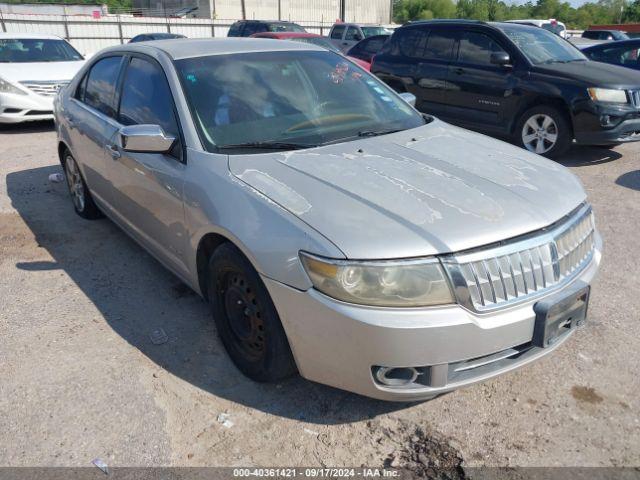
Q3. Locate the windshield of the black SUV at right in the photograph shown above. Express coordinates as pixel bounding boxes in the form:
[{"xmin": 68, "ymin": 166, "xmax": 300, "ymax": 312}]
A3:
[{"xmin": 499, "ymin": 24, "xmax": 587, "ymax": 65}]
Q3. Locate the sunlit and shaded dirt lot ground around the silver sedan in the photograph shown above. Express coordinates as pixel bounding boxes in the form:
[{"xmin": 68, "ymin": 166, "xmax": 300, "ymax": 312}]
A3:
[{"xmin": 0, "ymin": 123, "xmax": 640, "ymax": 468}]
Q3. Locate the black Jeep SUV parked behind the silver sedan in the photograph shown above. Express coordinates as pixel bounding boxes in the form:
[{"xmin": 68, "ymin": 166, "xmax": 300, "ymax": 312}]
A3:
[{"xmin": 371, "ymin": 20, "xmax": 640, "ymax": 157}]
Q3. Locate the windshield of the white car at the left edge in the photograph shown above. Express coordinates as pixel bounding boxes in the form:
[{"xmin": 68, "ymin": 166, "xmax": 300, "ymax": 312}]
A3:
[{"xmin": 0, "ymin": 38, "xmax": 82, "ymax": 63}]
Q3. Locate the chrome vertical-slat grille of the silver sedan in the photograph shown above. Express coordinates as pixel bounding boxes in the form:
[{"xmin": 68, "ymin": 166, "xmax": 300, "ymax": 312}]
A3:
[{"xmin": 443, "ymin": 205, "xmax": 595, "ymax": 311}]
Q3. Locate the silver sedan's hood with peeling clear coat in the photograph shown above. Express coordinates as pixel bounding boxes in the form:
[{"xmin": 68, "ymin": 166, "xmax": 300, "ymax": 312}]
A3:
[{"xmin": 229, "ymin": 120, "xmax": 586, "ymax": 259}]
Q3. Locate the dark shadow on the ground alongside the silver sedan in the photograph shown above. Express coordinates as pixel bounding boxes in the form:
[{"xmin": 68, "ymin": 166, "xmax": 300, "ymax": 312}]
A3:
[{"xmin": 7, "ymin": 164, "xmax": 407, "ymax": 424}]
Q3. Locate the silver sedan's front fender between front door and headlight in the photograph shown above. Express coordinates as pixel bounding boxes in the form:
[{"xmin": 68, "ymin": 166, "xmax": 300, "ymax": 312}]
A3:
[{"xmin": 184, "ymin": 149, "xmax": 344, "ymax": 291}]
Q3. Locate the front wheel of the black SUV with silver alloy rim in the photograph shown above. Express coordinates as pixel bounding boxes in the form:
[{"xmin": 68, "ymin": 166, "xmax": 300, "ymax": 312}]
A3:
[{"xmin": 514, "ymin": 105, "xmax": 573, "ymax": 158}]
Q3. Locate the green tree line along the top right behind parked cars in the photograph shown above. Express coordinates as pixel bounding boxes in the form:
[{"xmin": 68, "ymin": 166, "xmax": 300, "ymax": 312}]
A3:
[{"xmin": 393, "ymin": 0, "xmax": 640, "ymax": 29}]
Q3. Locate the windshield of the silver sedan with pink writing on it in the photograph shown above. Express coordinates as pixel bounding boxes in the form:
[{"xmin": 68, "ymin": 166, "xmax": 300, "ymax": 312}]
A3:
[{"xmin": 176, "ymin": 51, "xmax": 425, "ymax": 151}]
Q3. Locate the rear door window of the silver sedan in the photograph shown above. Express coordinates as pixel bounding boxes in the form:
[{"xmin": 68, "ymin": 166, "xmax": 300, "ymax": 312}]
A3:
[{"xmin": 83, "ymin": 56, "xmax": 122, "ymax": 118}]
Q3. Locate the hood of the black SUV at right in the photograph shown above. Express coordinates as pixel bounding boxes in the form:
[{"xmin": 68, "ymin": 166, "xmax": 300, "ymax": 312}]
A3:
[{"xmin": 533, "ymin": 60, "xmax": 640, "ymax": 89}]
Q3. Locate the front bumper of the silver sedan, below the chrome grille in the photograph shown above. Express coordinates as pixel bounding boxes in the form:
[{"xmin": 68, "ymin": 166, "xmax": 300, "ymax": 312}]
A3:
[{"xmin": 263, "ymin": 237, "xmax": 601, "ymax": 401}]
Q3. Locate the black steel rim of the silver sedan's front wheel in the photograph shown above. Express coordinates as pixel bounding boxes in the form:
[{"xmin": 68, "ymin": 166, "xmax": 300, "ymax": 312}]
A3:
[{"xmin": 220, "ymin": 272, "xmax": 266, "ymax": 359}]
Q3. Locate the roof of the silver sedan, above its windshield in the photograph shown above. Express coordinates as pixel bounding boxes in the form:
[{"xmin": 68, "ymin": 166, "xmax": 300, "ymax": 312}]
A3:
[{"xmin": 102, "ymin": 37, "xmax": 327, "ymax": 60}]
